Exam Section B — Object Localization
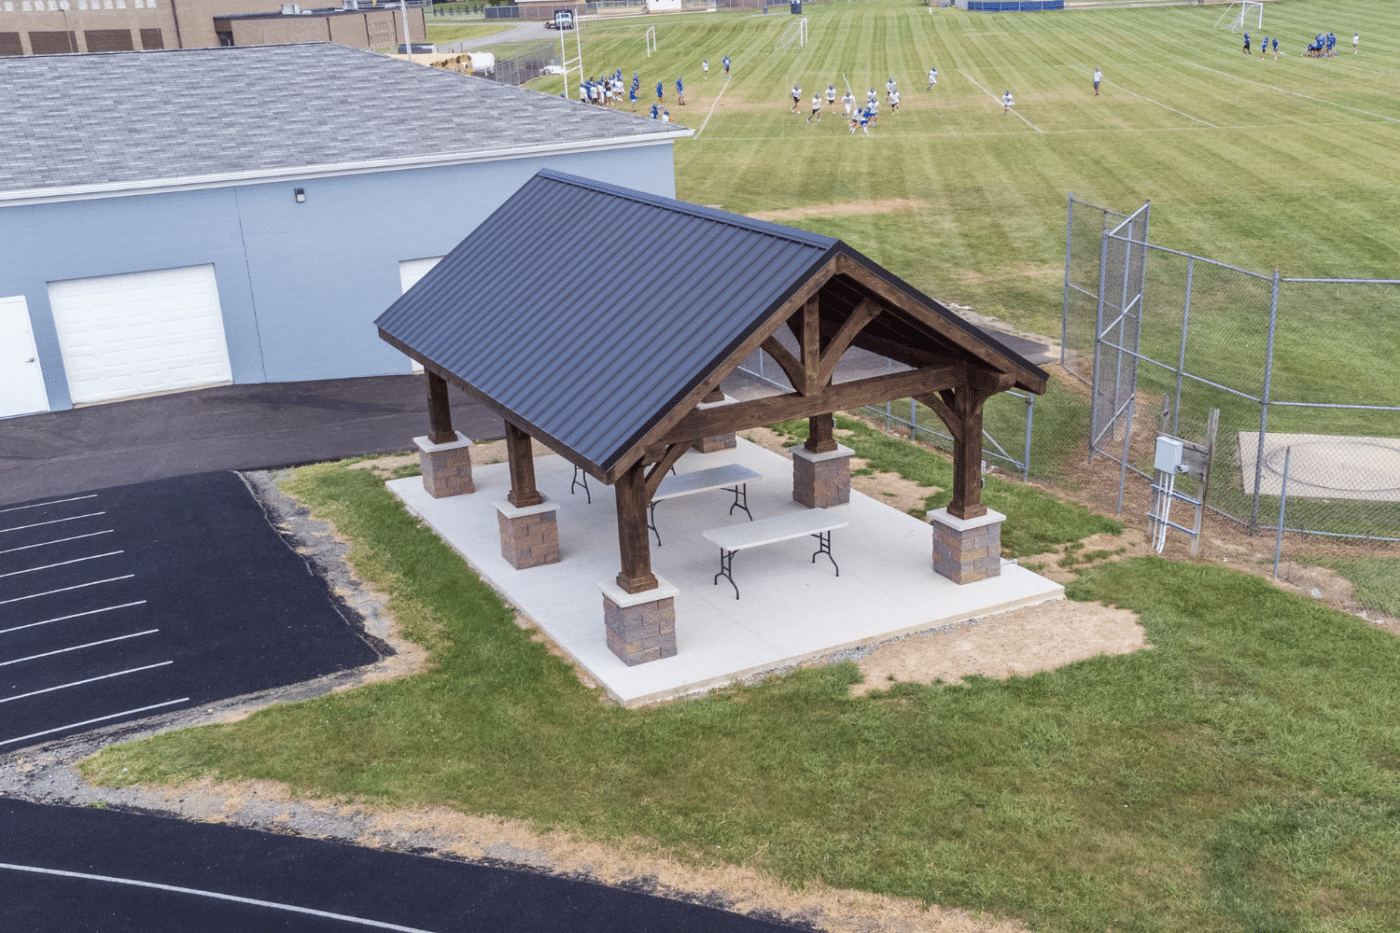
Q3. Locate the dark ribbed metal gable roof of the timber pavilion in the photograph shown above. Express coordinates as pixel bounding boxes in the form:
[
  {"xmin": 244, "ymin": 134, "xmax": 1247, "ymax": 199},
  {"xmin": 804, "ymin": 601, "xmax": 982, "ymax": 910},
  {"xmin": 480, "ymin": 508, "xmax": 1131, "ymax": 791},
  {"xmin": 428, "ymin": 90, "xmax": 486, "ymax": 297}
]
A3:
[{"xmin": 375, "ymin": 170, "xmax": 1044, "ymax": 472}]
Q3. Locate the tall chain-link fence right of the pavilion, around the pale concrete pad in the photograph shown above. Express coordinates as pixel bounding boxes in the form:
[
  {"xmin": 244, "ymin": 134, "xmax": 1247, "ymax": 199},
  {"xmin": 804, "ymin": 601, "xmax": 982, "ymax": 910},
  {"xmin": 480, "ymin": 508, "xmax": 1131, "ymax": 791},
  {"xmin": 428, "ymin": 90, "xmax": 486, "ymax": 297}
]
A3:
[{"xmin": 1063, "ymin": 195, "xmax": 1400, "ymax": 542}]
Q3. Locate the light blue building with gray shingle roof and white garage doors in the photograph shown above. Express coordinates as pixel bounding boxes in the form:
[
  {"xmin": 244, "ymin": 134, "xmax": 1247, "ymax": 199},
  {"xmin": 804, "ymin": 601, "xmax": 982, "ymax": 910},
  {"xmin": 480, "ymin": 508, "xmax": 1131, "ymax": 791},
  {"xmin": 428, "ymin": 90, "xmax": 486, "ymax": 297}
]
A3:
[{"xmin": 0, "ymin": 43, "xmax": 690, "ymax": 416}]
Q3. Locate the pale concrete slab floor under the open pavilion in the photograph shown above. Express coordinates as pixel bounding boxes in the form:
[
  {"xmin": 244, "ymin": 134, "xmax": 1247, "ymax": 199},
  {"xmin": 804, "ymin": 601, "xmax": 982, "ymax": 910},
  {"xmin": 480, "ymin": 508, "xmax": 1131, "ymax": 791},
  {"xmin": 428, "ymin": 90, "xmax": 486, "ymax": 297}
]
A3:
[{"xmin": 389, "ymin": 438, "xmax": 1064, "ymax": 706}]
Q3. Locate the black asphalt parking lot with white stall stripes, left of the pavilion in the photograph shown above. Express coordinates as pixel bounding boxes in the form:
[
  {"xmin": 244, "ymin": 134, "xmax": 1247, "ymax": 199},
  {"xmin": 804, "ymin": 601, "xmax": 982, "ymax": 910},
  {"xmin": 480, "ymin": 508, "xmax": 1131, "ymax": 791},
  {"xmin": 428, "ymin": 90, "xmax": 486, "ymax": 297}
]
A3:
[{"xmin": 0, "ymin": 472, "xmax": 379, "ymax": 754}]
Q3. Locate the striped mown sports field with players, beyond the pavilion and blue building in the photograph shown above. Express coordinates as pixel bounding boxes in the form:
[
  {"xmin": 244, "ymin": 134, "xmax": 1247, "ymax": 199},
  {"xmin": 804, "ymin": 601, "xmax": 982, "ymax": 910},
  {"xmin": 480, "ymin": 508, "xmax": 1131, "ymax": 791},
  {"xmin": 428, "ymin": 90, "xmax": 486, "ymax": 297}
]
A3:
[{"xmin": 532, "ymin": 0, "xmax": 1400, "ymax": 340}]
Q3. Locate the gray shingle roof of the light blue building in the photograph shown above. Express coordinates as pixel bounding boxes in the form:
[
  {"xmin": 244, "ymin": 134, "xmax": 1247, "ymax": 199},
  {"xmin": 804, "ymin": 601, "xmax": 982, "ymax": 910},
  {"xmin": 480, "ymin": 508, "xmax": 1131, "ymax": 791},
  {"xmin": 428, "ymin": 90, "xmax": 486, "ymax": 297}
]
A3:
[{"xmin": 0, "ymin": 42, "xmax": 689, "ymax": 192}]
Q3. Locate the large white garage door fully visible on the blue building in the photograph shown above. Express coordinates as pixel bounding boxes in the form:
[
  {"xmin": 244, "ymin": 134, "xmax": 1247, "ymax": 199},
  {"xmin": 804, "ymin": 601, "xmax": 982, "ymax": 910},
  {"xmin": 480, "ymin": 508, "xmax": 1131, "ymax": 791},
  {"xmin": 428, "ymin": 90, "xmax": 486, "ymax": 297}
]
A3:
[{"xmin": 49, "ymin": 265, "xmax": 232, "ymax": 403}]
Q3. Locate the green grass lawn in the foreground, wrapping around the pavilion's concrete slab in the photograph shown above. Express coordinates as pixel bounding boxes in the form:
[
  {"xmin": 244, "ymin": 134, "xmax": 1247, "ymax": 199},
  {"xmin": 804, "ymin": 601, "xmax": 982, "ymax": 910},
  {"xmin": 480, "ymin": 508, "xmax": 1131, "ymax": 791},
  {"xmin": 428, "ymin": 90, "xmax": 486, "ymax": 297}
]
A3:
[{"xmin": 84, "ymin": 448, "xmax": 1400, "ymax": 933}]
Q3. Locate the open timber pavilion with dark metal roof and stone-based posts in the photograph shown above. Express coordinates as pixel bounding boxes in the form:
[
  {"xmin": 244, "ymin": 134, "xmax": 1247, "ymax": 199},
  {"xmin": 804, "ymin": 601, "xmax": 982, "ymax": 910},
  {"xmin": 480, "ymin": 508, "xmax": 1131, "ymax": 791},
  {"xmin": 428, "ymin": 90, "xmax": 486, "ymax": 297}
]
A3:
[{"xmin": 375, "ymin": 170, "xmax": 1047, "ymax": 665}]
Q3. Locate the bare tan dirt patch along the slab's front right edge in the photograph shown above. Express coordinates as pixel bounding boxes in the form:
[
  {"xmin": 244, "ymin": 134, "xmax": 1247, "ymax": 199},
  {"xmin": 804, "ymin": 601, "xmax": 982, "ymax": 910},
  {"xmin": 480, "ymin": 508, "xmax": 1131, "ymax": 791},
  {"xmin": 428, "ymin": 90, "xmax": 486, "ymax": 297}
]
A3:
[{"xmin": 851, "ymin": 600, "xmax": 1151, "ymax": 696}]
